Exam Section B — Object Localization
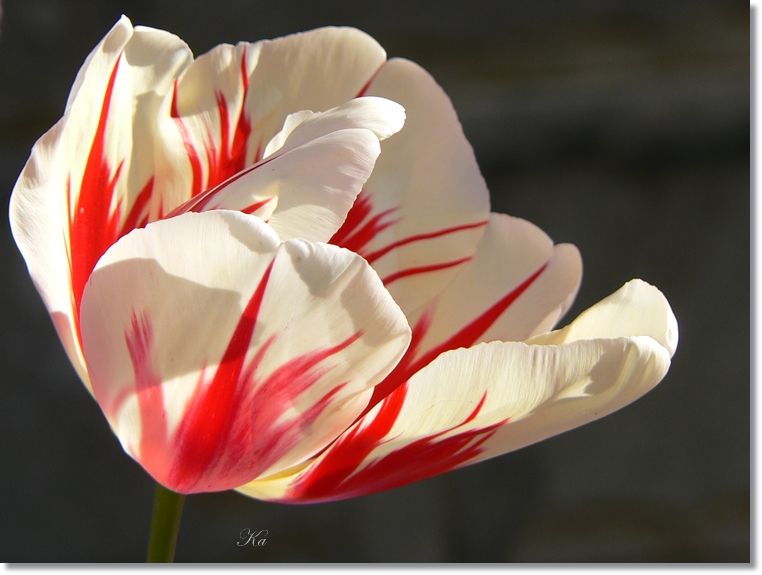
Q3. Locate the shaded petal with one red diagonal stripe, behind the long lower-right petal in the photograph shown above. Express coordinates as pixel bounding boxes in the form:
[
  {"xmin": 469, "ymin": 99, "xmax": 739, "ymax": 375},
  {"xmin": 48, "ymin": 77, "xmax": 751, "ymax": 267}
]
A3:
[{"xmin": 360, "ymin": 214, "xmax": 582, "ymax": 407}]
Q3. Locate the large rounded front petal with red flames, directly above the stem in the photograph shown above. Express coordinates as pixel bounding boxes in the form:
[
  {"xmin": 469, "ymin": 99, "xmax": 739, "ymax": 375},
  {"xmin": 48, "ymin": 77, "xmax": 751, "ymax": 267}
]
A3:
[{"xmin": 82, "ymin": 211, "xmax": 409, "ymax": 493}]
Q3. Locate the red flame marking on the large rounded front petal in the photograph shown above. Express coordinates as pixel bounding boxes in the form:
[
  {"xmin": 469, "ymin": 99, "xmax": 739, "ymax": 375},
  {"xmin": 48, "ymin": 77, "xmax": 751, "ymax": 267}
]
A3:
[{"xmin": 127, "ymin": 263, "xmax": 362, "ymax": 493}]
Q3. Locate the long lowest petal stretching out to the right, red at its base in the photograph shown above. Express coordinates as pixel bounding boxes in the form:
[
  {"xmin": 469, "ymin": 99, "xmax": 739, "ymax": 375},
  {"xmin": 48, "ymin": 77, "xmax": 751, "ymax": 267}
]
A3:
[{"xmin": 239, "ymin": 288, "xmax": 671, "ymax": 503}]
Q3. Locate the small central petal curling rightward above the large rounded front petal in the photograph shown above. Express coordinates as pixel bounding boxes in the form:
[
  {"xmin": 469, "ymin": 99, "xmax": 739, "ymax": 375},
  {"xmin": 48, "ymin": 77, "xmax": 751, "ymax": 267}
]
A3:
[{"xmin": 170, "ymin": 98, "xmax": 405, "ymax": 241}]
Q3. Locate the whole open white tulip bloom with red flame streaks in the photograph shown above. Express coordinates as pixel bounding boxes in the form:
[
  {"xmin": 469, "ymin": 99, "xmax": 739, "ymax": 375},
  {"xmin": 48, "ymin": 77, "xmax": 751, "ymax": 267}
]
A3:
[{"xmin": 10, "ymin": 17, "xmax": 678, "ymax": 560}]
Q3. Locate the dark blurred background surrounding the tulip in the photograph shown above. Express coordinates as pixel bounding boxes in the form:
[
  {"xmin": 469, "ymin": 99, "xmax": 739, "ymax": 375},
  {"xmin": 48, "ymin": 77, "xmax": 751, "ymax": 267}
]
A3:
[{"xmin": 0, "ymin": 0, "xmax": 750, "ymax": 562}]
